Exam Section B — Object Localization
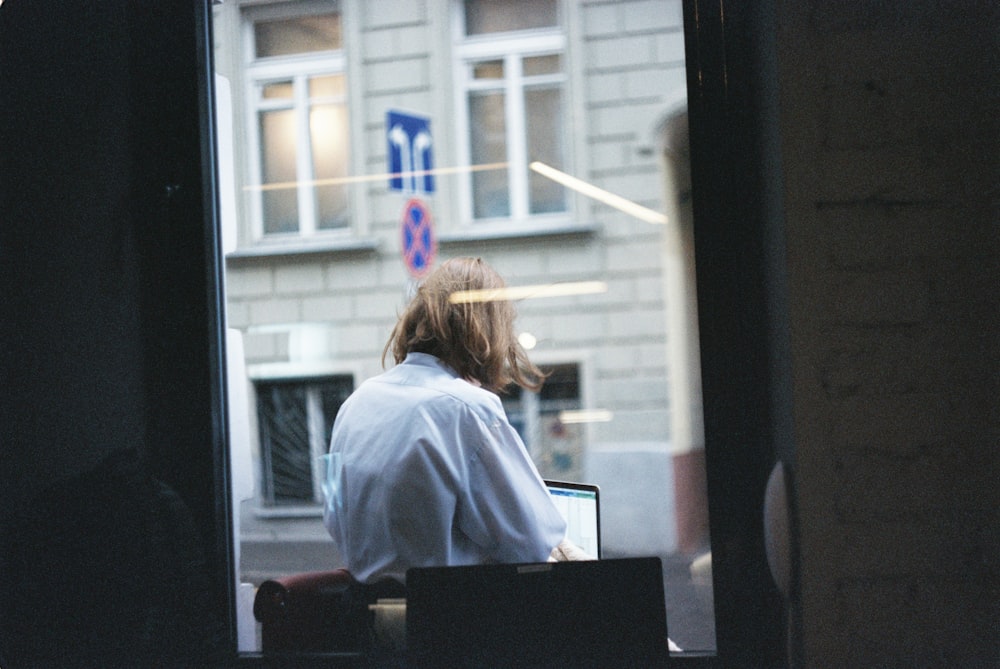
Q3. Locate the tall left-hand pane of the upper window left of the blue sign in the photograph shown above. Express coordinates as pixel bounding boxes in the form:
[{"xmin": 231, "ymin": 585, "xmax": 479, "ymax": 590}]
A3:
[{"xmin": 260, "ymin": 110, "xmax": 299, "ymax": 234}]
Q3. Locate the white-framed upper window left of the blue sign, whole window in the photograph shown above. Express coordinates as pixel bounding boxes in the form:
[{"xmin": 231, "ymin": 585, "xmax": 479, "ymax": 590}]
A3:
[{"xmin": 244, "ymin": 2, "xmax": 350, "ymax": 239}]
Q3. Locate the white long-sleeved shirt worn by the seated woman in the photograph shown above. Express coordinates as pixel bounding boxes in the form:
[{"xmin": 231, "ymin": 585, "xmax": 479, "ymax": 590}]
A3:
[{"xmin": 324, "ymin": 353, "xmax": 566, "ymax": 583}]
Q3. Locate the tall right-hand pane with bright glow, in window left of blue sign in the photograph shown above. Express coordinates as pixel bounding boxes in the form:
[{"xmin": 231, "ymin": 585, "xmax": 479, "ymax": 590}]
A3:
[{"xmin": 309, "ymin": 105, "xmax": 349, "ymax": 230}]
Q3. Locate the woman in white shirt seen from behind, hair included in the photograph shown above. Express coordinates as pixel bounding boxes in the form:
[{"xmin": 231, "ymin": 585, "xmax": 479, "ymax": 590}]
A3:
[{"xmin": 324, "ymin": 258, "xmax": 565, "ymax": 583}]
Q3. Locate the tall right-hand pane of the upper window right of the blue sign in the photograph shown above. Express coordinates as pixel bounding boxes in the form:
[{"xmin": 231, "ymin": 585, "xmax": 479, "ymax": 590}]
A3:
[{"xmin": 524, "ymin": 88, "xmax": 566, "ymax": 214}]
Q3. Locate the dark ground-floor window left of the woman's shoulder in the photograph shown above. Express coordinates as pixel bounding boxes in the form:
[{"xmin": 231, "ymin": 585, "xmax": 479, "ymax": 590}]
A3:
[{"xmin": 254, "ymin": 375, "xmax": 354, "ymax": 508}]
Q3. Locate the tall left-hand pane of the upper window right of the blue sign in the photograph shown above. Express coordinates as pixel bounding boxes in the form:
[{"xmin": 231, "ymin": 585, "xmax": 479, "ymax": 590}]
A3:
[{"xmin": 469, "ymin": 93, "xmax": 510, "ymax": 218}]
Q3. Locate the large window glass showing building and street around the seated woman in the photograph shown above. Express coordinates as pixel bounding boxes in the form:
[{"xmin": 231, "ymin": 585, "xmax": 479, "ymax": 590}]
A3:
[{"xmin": 213, "ymin": 0, "xmax": 715, "ymax": 653}]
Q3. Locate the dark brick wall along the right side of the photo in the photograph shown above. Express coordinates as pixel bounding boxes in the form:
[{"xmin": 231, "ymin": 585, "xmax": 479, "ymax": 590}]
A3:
[{"xmin": 776, "ymin": 1, "xmax": 1000, "ymax": 667}]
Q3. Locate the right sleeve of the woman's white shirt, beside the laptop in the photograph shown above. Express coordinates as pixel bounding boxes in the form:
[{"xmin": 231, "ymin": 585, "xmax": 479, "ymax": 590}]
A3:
[{"xmin": 456, "ymin": 404, "xmax": 566, "ymax": 562}]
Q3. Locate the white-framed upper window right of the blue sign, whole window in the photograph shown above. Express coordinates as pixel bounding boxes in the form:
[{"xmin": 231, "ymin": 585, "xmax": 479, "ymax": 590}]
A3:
[{"xmin": 455, "ymin": 0, "xmax": 568, "ymax": 221}]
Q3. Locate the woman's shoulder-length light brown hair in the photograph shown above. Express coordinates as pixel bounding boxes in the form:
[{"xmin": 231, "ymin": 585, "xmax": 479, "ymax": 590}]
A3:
[{"xmin": 382, "ymin": 258, "xmax": 545, "ymax": 392}]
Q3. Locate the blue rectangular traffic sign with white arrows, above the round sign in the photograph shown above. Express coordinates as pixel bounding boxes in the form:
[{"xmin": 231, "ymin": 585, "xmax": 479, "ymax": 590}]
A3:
[{"xmin": 385, "ymin": 109, "xmax": 434, "ymax": 195}]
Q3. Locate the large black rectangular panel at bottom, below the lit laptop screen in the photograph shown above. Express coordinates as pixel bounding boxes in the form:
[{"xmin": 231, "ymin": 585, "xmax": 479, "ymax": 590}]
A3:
[{"xmin": 406, "ymin": 557, "xmax": 669, "ymax": 669}]
